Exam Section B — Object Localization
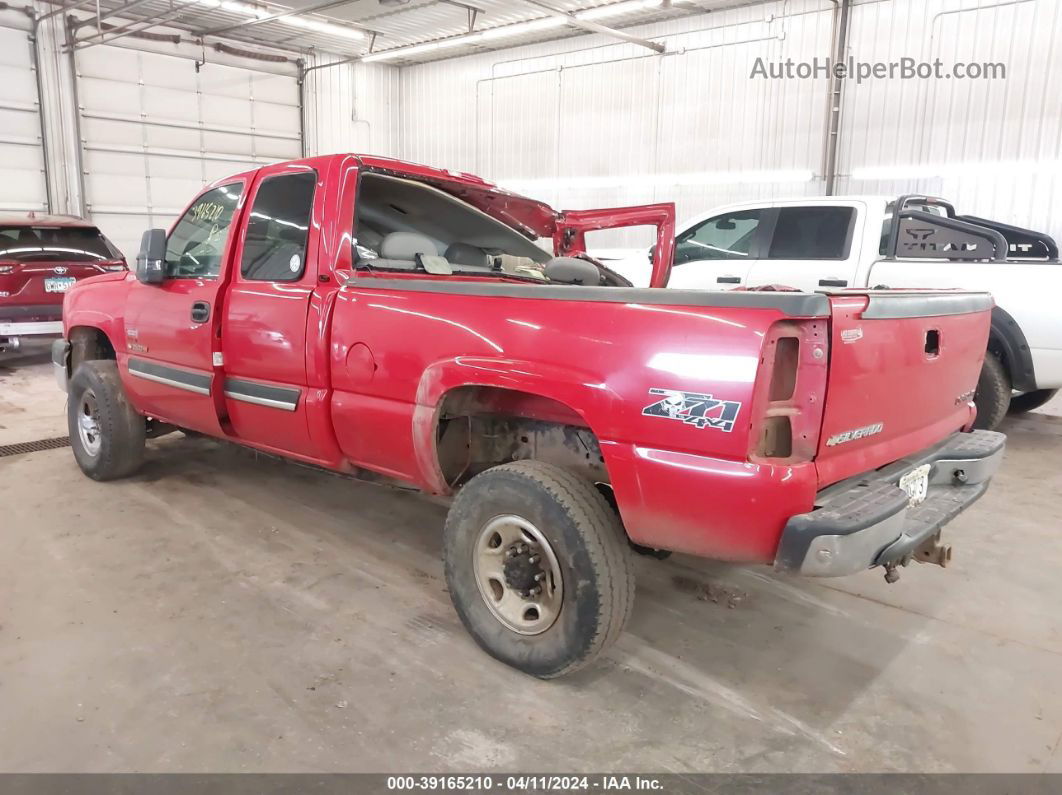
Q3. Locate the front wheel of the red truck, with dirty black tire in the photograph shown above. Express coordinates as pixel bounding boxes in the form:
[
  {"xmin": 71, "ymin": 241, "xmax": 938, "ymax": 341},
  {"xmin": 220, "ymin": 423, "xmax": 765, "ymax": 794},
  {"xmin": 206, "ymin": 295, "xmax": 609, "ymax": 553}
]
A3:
[{"xmin": 67, "ymin": 360, "xmax": 147, "ymax": 481}]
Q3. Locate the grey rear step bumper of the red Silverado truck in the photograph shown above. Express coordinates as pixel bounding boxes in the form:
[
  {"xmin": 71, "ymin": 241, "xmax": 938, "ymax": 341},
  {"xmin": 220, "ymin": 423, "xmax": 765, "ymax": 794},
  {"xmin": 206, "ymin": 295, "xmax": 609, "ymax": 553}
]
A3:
[{"xmin": 774, "ymin": 431, "xmax": 1006, "ymax": 576}]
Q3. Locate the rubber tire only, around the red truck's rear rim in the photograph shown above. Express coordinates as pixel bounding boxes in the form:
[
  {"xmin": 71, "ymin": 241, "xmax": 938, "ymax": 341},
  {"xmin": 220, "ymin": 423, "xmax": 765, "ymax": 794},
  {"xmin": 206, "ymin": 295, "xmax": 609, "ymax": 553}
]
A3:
[{"xmin": 444, "ymin": 461, "xmax": 634, "ymax": 679}]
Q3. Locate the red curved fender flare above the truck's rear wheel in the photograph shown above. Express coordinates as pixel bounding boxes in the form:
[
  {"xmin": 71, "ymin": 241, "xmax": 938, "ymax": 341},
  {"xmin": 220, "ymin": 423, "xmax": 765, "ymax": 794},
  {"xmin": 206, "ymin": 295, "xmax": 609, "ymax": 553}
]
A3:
[{"xmin": 412, "ymin": 357, "xmax": 618, "ymax": 494}]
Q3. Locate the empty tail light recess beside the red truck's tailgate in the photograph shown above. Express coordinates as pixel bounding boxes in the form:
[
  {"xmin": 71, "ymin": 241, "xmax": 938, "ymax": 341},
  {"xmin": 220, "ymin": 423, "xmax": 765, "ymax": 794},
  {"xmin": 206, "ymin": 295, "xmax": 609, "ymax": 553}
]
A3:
[{"xmin": 749, "ymin": 319, "xmax": 829, "ymax": 464}]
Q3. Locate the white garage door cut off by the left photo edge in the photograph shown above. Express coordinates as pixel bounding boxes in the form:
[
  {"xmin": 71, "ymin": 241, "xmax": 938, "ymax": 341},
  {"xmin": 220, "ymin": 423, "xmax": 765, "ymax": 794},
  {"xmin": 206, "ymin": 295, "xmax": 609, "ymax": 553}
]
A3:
[{"xmin": 0, "ymin": 27, "xmax": 48, "ymax": 212}]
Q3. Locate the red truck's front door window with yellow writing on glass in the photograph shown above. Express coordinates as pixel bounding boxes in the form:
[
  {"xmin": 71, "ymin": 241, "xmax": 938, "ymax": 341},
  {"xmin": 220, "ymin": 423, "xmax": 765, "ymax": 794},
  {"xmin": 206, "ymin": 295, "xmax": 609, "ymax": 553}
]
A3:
[{"xmin": 166, "ymin": 184, "xmax": 243, "ymax": 279}]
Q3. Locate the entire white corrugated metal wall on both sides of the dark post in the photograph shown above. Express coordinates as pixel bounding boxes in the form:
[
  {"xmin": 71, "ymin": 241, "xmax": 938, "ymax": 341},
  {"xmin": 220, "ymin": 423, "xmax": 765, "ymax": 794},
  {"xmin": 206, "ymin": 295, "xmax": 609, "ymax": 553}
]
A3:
[{"xmin": 386, "ymin": 0, "xmax": 1062, "ymax": 245}]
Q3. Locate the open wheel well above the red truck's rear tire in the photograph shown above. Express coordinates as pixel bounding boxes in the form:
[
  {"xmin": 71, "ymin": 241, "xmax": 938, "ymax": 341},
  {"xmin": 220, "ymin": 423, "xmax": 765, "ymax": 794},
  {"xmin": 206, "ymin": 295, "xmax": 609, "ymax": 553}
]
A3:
[{"xmin": 435, "ymin": 386, "xmax": 611, "ymax": 488}]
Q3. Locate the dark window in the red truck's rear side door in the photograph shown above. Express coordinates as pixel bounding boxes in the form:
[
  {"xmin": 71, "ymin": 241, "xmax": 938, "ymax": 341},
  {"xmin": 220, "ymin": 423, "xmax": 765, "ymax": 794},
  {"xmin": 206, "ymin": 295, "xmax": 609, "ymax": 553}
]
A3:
[{"xmin": 240, "ymin": 171, "xmax": 318, "ymax": 281}]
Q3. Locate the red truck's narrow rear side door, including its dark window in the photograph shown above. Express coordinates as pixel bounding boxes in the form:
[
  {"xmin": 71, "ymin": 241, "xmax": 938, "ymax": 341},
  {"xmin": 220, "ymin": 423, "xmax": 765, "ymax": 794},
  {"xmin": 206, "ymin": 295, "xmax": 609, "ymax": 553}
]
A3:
[{"xmin": 214, "ymin": 163, "xmax": 314, "ymax": 455}]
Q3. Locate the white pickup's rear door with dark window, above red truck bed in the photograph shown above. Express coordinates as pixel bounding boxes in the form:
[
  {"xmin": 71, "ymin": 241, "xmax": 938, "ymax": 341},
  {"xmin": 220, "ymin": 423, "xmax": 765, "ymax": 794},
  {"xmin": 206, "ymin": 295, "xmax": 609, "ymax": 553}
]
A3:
[{"xmin": 748, "ymin": 202, "xmax": 862, "ymax": 292}]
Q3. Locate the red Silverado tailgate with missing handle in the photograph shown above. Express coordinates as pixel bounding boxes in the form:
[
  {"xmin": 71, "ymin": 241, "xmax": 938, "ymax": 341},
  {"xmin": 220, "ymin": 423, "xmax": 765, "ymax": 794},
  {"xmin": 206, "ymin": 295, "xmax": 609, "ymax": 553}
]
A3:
[{"xmin": 816, "ymin": 291, "xmax": 993, "ymax": 488}]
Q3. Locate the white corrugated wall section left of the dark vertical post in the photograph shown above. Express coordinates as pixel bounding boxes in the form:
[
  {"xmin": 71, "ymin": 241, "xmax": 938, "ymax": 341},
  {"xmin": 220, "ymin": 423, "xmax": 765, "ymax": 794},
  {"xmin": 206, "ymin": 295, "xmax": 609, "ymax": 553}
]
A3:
[{"xmin": 399, "ymin": 0, "xmax": 834, "ymax": 245}]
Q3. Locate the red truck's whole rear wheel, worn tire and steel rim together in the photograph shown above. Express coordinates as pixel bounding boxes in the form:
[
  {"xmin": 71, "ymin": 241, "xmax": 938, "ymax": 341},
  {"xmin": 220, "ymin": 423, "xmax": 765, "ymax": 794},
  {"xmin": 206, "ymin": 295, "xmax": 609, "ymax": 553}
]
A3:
[{"xmin": 444, "ymin": 461, "xmax": 634, "ymax": 679}]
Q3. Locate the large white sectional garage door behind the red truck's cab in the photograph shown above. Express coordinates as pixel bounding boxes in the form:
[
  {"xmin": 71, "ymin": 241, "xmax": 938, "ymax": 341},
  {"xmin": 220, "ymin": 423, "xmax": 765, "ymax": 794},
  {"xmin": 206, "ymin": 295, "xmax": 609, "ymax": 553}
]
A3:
[{"xmin": 78, "ymin": 46, "xmax": 301, "ymax": 261}]
